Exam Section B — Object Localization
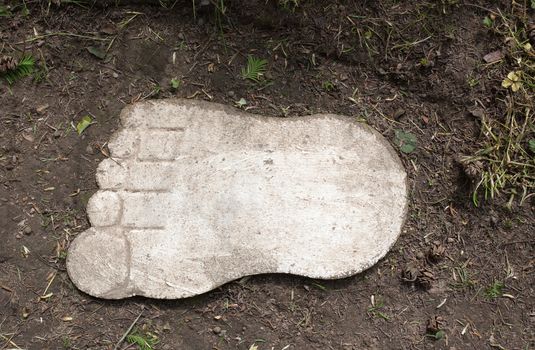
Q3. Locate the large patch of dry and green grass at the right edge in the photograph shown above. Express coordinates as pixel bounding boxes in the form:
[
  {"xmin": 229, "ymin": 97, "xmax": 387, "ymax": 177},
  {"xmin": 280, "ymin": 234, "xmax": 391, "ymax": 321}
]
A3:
[{"xmin": 462, "ymin": 6, "xmax": 535, "ymax": 208}]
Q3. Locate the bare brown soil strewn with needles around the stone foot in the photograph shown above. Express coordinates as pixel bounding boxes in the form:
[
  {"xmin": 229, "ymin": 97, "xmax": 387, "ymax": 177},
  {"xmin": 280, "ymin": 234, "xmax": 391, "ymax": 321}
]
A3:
[{"xmin": 0, "ymin": 0, "xmax": 535, "ymax": 350}]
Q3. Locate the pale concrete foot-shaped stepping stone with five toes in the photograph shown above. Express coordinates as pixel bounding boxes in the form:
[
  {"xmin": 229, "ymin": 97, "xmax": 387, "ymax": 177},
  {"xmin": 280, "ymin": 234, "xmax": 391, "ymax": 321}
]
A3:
[{"xmin": 67, "ymin": 100, "xmax": 407, "ymax": 299}]
